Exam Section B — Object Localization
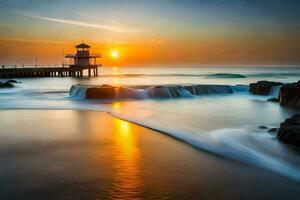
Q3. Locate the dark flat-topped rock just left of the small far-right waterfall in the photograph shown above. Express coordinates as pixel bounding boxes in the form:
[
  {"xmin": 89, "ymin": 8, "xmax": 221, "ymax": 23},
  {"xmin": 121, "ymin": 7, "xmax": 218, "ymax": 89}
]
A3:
[{"xmin": 250, "ymin": 81, "xmax": 283, "ymax": 95}]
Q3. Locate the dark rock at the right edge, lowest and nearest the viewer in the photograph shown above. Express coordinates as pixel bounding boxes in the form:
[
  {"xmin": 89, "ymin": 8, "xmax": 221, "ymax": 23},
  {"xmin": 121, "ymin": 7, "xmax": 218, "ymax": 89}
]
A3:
[{"xmin": 277, "ymin": 115, "xmax": 300, "ymax": 147}]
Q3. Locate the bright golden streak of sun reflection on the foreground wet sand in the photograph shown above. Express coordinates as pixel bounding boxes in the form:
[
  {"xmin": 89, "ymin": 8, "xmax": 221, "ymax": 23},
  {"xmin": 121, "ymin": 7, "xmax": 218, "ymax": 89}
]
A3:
[{"xmin": 110, "ymin": 119, "xmax": 143, "ymax": 199}]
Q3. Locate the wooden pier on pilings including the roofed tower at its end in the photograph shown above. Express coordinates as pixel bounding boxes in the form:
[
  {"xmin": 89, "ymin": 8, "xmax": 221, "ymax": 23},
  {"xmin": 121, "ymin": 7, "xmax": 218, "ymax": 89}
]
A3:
[{"xmin": 0, "ymin": 43, "xmax": 102, "ymax": 78}]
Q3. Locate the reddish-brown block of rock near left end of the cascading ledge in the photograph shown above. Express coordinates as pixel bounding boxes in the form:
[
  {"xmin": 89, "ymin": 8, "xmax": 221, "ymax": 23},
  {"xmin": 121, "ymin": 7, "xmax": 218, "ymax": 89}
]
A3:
[{"xmin": 85, "ymin": 85, "xmax": 115, "ymax": 99}]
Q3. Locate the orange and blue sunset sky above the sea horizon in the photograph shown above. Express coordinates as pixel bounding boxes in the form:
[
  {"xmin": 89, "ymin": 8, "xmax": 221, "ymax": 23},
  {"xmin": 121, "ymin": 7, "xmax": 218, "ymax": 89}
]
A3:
[{"xmin": 0, "ymin": 0, "xmax": 300, "ymax": 66}]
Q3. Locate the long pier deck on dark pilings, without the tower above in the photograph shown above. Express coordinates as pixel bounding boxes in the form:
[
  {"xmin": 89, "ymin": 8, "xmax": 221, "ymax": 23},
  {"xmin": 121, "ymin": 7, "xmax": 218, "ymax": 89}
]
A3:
[{"xmin": 0, "ymin": 64, "xmax": 102, "ymax": 78}]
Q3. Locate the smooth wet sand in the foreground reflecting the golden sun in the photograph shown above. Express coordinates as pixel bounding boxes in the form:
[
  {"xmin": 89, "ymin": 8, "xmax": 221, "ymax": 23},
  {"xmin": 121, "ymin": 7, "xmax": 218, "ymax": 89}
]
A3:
[{"xmin": 0, "ymin": 110, "xmax": 300, "ymax": 199}]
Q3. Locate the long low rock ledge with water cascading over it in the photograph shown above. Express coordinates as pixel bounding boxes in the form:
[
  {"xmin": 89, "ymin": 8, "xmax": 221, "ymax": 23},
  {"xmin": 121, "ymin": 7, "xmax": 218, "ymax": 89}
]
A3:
[{"xmin": 69, "ymin": 85, "xmax": 248, "ymax": 99}]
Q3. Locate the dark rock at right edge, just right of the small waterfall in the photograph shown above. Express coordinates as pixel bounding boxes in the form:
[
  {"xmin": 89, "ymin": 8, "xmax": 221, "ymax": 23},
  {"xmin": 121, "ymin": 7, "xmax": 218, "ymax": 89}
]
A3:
[{"xmin": 279, "ymin": 81, "xmax": 300, "ymax": 107}]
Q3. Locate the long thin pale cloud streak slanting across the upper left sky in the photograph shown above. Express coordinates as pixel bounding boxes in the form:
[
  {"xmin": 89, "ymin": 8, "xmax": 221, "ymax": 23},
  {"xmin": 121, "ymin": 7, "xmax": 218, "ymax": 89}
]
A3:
[{"xmin": 17, "ymin": 9, "xmax": 140, "ymax": 33}]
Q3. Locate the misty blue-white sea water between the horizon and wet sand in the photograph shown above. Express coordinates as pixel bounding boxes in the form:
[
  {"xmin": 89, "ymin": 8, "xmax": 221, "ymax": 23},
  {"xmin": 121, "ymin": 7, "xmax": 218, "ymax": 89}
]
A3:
[{"xmin": 0, "ymin": 67, "xmax": 300, "ymax": 181}]
